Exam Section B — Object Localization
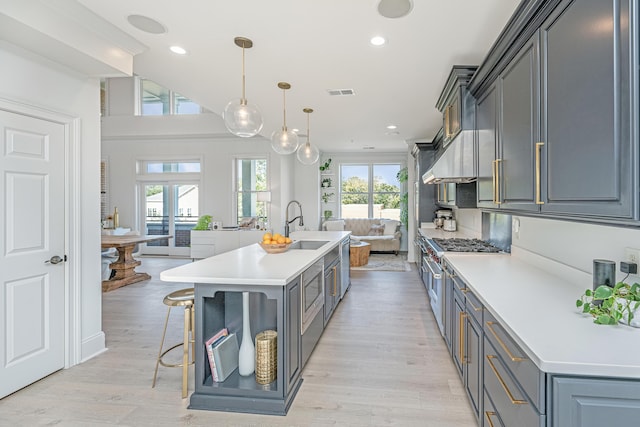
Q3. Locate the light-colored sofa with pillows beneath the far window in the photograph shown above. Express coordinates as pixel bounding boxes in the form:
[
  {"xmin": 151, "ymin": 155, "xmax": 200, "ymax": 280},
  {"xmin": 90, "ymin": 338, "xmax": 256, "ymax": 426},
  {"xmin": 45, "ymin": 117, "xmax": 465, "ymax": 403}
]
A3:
[{"xmin": 322, "ymin": 218, "xmax": 402, "ymax": 255}]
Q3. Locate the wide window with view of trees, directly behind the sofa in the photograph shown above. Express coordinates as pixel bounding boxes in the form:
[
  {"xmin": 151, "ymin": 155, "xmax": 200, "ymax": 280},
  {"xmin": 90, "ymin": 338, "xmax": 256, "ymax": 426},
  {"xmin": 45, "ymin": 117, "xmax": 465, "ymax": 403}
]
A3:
[{"xmin": 340, "ymin": 164, "xmax": 402, "ymax": 220}]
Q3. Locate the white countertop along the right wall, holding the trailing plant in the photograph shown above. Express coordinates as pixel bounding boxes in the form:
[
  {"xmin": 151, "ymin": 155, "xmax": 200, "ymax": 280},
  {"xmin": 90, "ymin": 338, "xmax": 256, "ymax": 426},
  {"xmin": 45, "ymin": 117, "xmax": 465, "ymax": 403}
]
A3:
[{"xmin": 445, "ymin": 253, "xmax": 640, "ymax": 378}]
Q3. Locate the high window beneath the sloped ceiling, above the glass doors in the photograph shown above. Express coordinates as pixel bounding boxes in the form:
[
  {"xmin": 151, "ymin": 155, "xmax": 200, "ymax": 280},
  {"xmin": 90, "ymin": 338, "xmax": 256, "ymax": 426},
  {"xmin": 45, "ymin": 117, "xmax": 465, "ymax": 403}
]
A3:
[{"xmin": 140, "ymin": 79, "xmax": 202, "ymax": 116}]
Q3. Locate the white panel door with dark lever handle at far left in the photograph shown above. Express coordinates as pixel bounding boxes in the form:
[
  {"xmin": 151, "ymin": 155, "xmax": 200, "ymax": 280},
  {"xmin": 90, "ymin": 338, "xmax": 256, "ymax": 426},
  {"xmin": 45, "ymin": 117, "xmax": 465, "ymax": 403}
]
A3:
[{"xmin": 0, "ymin": 110, "xmax": 66, "ymax": 398}]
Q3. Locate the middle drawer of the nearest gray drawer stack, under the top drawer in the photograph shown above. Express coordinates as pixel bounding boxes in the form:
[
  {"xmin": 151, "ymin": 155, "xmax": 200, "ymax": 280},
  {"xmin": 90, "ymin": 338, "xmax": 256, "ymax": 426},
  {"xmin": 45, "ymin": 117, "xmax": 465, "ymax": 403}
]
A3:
[{"xmin": 484, "ymin": 338, "xmax": 546, "ymax": 427}]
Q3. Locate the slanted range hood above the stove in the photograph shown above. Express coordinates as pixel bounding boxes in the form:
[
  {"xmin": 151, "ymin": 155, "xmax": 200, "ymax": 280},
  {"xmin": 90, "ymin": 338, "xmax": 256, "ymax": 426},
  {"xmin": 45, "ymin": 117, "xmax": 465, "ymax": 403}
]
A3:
[{"xmin": 422, "ymin": 130, "xmax": 478, "ymax": 184}]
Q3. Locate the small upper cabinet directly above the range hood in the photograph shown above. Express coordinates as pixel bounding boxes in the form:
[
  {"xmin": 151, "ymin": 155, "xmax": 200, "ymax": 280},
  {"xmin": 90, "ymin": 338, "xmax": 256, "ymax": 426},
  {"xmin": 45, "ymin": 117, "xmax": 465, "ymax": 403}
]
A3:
[{"xmin": 436, "ymin": 65, "xmax": 478, "ymax": 147}]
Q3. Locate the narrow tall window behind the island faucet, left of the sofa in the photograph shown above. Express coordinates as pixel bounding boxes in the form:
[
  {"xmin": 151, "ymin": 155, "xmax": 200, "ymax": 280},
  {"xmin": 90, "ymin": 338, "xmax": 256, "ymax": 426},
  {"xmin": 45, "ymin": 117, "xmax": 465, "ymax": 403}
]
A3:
[{"xmin": 235, "ymin": 158, "xmax": 268, "ymax": 224}]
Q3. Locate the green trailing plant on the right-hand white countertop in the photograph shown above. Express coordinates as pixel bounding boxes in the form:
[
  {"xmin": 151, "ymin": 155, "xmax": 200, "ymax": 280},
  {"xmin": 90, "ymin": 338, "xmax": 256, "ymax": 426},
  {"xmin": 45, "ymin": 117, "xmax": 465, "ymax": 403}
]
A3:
[{"xmin": 576, "ymin": 282, "xmax": 640, "ymax": 325}]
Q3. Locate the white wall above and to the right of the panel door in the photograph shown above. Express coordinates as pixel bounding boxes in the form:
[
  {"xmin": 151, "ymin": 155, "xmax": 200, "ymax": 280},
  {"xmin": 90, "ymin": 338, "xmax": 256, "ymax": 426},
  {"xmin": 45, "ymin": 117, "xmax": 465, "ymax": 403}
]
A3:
[{"xmin": 0, "ymin": 42, "xmax": 104, "ymax": 363}]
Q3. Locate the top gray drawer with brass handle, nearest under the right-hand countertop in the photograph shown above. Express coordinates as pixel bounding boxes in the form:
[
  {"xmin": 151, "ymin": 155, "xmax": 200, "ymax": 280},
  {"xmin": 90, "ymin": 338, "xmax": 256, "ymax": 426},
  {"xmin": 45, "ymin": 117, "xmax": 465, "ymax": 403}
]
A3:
[{"xmin": 484, "ymin": 311, "xmax": 546, "ymax": 413}]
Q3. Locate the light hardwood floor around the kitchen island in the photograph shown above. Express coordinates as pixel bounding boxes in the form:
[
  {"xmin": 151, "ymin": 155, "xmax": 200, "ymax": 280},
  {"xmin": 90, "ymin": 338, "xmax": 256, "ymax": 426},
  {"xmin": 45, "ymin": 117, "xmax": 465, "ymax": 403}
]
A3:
[{"xmin": 0, "ymin": 258, "xmax": 476, "ymax": 427}]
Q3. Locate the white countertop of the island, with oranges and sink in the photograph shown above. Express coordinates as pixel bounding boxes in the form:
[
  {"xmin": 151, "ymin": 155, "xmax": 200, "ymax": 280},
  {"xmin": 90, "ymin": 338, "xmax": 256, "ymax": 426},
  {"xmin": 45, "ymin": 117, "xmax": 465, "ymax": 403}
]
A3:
[{"xmin": 160, "ymin": 231, "xmax": 351, "ymax": 286}]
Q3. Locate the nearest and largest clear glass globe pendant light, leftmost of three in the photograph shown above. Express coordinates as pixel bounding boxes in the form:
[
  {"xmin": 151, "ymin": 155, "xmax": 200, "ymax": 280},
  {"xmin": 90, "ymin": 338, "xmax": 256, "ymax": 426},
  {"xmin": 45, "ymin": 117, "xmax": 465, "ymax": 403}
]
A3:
[{"xmin": 223, "ymin": 37, "xmax": 263, "ymax": 138}]
